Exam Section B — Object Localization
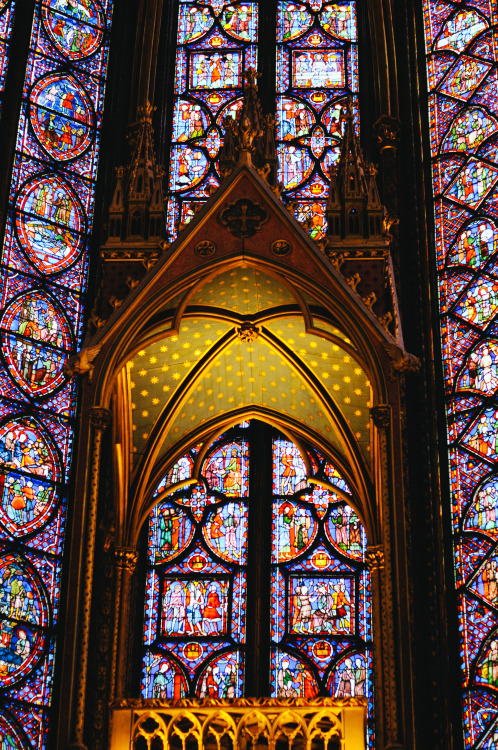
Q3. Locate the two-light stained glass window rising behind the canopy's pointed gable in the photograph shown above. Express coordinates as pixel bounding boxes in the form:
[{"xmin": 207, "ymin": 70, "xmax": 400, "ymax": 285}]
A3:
[{"xmin": 168, "ymin": 0, "xmax": 358, "ymax": 239}]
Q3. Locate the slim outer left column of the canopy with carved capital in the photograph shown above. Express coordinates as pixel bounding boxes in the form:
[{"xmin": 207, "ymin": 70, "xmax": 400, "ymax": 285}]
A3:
[{"xmin": 70, "ymin": 406, "xmax": 111, "ymax": 750}]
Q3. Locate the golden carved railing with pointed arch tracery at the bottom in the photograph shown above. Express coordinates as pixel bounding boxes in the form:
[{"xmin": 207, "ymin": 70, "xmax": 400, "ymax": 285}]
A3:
[{"xmin": 111, "ymin": 698, "xmax": 366, "ymax": 750}]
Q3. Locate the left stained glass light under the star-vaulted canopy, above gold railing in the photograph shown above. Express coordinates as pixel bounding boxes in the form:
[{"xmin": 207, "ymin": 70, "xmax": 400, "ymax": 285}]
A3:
[{"xmin": 142, "ymin": 437, "xmax": 249, "ymax": 698}]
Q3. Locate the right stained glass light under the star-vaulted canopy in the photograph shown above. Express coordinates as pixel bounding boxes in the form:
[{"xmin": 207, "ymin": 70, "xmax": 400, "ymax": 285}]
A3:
[{"xmin": 271, "ymin": 439, "xmax": 373, "ymax": 745}]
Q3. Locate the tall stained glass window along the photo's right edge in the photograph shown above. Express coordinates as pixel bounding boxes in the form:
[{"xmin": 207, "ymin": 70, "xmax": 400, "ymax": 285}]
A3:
[{"xmin": 424, "ymin": 0, "xmax": 498, "ymax": 748}]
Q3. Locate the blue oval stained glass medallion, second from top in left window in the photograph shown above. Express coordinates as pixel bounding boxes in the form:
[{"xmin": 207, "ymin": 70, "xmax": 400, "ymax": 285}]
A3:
[{"xmin": 30, "ymin": 73, "xmax": 95, "ymax": 161}]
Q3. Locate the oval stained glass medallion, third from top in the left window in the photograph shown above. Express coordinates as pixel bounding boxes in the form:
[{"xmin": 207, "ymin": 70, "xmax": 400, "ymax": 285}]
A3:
[{"xmin": 16, "ymin": 176, "xmax": 85, "ymax": 274}]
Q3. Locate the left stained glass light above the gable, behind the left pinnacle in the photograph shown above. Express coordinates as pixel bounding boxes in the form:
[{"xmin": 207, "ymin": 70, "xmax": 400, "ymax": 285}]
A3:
[{"xmin": 168, "ymin": 0, "xmax": 258, "ymax": 239}]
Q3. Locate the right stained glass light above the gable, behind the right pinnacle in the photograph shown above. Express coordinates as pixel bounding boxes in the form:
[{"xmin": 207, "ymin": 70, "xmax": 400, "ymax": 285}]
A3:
[{"xmin": 276, "ymin": 0, "xmax": 358, "ymax": 239}]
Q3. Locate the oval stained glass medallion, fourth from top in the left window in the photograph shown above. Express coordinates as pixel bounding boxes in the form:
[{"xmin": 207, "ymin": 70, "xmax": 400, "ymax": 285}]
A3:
[{"xmin": 0, "ymin": 291, "xmax": 71, "ymax": 397}]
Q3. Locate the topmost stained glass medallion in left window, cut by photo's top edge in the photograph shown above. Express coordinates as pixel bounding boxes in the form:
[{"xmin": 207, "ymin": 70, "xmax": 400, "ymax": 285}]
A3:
[{"xmin": 42, "ymin": 0, "xmax": 104, "ymax": 60}]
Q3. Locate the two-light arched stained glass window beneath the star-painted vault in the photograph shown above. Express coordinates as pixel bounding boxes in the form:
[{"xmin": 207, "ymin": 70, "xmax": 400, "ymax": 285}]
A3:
[{"xmin": 142, "ymin": 423, "xmax": 373, "ymax": 732}]
